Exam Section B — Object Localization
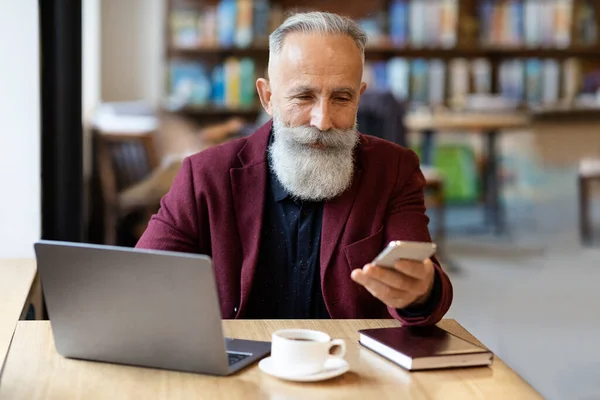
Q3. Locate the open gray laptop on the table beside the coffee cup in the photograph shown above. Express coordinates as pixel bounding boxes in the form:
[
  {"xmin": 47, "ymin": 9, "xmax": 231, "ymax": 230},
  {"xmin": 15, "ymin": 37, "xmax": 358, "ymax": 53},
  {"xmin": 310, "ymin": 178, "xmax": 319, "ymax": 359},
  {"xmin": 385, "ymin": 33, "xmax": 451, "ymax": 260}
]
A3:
[{"xmin": 34, "ymin": 240, "xmax": 271, "ymax": 375}]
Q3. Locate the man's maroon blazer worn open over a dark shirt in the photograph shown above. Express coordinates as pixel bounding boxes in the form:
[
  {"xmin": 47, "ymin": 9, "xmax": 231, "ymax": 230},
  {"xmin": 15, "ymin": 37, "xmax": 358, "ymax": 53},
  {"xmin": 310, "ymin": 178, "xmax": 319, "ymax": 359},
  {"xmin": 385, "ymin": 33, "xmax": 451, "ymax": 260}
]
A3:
[{"xmin": 137, "ymin": 121, "xmax": 452, "ymax": 325}]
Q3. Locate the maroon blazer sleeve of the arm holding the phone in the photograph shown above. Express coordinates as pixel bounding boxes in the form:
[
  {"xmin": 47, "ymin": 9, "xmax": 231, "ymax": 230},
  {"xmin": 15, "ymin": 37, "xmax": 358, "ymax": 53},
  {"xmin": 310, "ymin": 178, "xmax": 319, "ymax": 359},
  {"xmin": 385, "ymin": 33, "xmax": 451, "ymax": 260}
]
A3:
[{"xmin": 385, "ymin": 151, "xmax": 452, "ymax": 325}]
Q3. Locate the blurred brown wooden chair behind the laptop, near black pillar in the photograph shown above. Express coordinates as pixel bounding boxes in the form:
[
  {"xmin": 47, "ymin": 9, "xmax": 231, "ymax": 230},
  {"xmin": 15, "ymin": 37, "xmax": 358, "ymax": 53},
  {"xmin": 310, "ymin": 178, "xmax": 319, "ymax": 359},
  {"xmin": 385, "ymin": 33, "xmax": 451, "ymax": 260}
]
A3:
[{"xmin": 93, "ymin": 129, "xmax": 159, "ymax": 245}]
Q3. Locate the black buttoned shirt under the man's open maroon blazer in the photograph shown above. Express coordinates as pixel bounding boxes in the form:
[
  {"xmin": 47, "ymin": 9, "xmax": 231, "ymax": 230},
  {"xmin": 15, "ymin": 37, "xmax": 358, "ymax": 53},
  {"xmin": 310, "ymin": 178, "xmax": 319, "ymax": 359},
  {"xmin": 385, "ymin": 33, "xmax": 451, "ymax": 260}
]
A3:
[{"xmin": 245, "ymin": 153, "xmax": 329, "ymax": 319}]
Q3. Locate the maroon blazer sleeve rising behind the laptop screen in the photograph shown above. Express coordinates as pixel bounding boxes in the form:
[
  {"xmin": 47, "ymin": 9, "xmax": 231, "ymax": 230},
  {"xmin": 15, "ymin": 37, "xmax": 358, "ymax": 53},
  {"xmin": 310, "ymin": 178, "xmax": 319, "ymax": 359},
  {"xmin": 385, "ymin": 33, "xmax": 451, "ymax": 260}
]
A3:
[{"xmin": 136, "ymin": 158, "xmax": 198, "ymax": 253}]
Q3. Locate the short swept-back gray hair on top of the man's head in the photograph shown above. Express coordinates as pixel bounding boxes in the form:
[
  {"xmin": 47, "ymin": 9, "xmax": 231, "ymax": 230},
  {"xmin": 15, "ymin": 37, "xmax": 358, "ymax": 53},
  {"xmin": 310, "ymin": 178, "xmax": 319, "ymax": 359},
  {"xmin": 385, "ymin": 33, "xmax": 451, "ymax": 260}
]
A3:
[{"xmin": 269, "ymin": 11, "xmax": 367, "ymax": 64}]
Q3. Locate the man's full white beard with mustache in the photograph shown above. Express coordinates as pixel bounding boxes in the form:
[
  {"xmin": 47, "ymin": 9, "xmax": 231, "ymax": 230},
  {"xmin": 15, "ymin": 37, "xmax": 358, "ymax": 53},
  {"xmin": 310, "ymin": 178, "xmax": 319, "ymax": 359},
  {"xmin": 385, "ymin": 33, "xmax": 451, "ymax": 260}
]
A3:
[{"xmin": 269, "ymin": 115, "xmax": 359, "ymax": 201}]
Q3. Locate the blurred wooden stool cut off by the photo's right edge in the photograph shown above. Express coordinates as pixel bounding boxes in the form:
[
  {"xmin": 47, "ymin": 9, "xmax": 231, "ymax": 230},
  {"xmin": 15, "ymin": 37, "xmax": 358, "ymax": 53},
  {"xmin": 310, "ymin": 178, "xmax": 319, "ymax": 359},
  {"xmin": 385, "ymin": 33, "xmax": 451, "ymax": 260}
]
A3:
[{"xmin": 579, "ymin": 159, "xmax": 600, "ymax": 244}]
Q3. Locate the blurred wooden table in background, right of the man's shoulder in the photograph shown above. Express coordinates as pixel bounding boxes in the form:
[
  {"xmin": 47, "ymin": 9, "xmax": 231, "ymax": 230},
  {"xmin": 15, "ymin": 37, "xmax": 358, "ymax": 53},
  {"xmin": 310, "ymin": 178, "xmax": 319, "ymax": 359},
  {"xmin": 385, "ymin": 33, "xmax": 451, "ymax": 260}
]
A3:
[{"xmin": 405, "ymin": 112, "xmax": 531, "ymax": 234}]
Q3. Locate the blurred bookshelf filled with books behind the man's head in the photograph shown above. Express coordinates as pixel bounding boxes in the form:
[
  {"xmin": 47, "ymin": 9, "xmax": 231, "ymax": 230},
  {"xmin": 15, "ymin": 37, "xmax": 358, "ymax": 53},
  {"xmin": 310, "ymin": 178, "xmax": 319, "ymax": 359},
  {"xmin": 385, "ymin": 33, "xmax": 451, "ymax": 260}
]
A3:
[{"xmin": 165, "ymin": 0, "xmax": 600, "ymax": 121}]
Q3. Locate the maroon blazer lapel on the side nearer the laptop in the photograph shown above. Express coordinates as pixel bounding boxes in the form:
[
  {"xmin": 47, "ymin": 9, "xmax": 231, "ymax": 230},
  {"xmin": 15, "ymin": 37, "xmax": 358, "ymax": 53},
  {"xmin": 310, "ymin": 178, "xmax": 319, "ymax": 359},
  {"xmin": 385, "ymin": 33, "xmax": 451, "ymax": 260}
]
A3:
[{"xmin": 229, "ymin": 122, "xmax": 271, "ymax": 316}]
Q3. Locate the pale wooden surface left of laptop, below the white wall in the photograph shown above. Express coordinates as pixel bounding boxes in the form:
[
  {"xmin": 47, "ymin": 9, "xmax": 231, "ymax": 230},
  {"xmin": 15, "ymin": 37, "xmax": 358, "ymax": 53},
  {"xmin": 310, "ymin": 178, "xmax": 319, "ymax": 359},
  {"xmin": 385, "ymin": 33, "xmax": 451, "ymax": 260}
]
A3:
[{"xmin": 0, "ymin": 259, "xmax": 36, "ymax": 370}]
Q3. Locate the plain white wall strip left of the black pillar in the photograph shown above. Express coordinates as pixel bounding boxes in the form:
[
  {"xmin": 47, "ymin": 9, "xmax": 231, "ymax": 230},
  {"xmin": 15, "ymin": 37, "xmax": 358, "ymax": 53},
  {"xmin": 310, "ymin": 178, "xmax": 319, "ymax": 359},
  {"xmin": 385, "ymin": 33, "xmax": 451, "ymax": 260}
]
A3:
[{"xmin": 0, "ymin": 0, "xmax": 41, "ymax": 258}]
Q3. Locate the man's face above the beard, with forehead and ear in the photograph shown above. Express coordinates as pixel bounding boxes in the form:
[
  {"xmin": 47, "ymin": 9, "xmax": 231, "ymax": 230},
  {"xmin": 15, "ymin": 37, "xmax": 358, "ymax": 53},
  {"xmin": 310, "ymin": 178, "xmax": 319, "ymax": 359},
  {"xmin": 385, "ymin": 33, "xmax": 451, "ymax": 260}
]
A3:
[{"xmin": 258, "ymin": 33, "xmax": 366, "ymax": 131}]
